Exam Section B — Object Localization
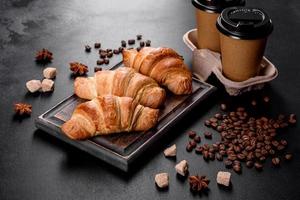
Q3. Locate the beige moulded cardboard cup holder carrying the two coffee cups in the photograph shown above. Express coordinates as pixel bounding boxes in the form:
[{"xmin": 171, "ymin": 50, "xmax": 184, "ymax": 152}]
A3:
[{"xmin": 183, "ymin": 29, "xmax": 278, "ymax": 96}]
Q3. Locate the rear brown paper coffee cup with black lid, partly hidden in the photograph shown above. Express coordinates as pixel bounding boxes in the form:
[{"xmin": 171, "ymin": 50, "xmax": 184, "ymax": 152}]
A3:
[{"xmin": 192, "ymin": 0, "xmax": 245, "ymax": 52}]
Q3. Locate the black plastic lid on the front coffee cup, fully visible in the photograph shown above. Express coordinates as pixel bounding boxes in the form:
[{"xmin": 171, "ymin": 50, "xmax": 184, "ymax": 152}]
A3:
[{"xmin": 217, "ymin": 7, "xmax": 273, "ymax": 39}]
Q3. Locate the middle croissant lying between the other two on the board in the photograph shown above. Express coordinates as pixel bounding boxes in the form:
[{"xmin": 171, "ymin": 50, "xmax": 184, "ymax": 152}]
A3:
[{"xmin": 74, "ymin": 67, "xmax": 166, "ymax": 108}]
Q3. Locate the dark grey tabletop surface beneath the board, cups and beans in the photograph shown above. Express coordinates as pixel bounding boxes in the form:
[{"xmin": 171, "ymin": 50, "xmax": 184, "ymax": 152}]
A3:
[{"xmin": 0, "ymin": 0, "xmax": 300, "ymax": 200}]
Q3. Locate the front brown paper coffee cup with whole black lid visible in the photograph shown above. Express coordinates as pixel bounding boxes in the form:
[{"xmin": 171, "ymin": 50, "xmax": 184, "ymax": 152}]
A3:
[{"xmin": 216, "ymin": 7, "xmax": 273, "ymax": 81}]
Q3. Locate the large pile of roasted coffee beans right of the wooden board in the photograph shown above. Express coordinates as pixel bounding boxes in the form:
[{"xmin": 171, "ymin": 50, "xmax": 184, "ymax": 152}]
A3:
[{"xmin": 186, "ymin": 98, "xmax": 296, "ymax": 173}]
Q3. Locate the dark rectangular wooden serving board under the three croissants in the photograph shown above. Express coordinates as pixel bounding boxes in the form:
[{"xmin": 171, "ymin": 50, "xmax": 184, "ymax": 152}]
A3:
[{"xmin": 36, "ymin": 61, "xmax": 215, "ymax": 171}]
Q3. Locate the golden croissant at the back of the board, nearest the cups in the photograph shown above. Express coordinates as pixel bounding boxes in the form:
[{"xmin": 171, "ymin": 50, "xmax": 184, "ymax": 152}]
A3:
[{"xmin": 123, "ymin": 47, "xmax": 192, "ymax": 95}]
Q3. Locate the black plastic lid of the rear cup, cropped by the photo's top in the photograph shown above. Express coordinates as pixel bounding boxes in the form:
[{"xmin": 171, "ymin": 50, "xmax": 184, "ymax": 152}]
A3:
[{"xmin": 192, "ymin": 0, "xmax": 245, "ymax": 13}]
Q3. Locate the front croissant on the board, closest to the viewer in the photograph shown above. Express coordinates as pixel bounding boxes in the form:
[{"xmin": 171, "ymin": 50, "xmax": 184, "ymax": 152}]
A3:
[{"xmin": 61, "ymin": 95, "xmax": 159, "ymax": 140}]
